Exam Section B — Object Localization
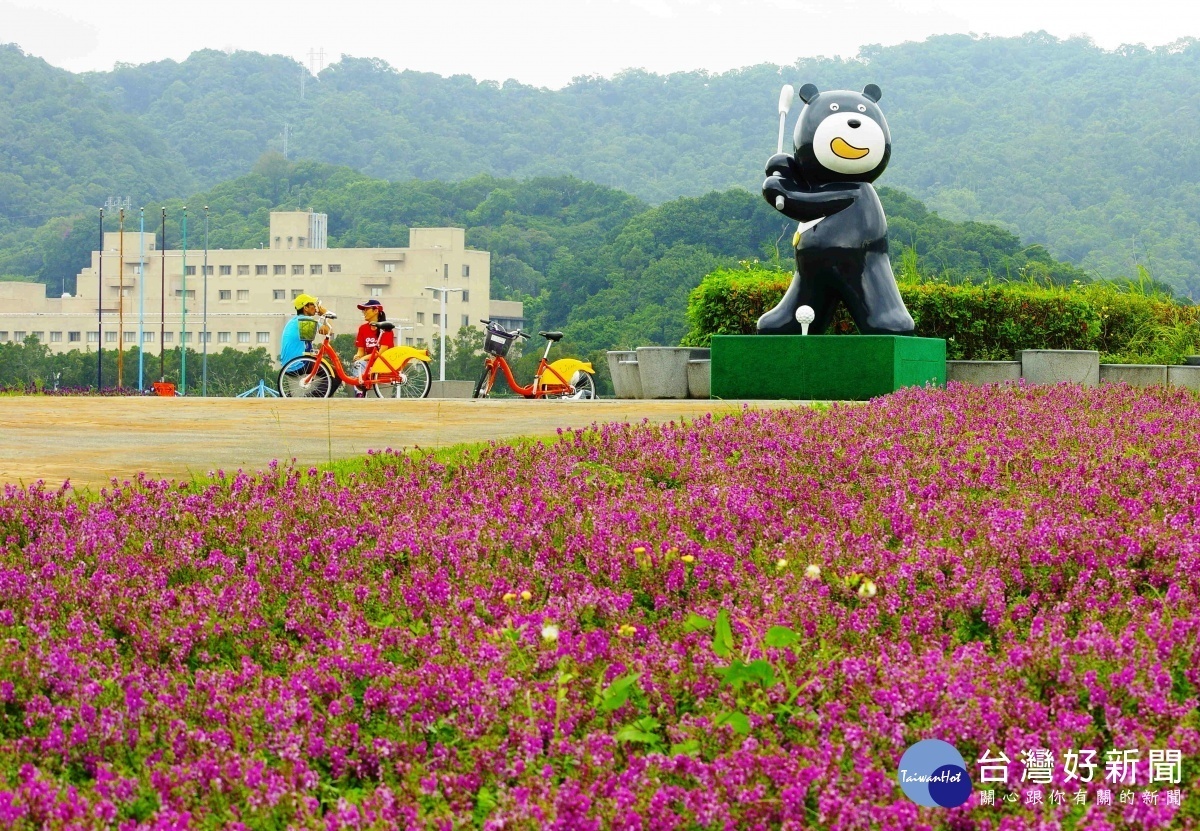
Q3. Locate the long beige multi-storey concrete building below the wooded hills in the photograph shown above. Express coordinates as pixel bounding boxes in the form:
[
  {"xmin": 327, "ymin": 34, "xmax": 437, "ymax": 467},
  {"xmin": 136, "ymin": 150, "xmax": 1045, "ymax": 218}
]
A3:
[{"xmin": 0, "ymin": 211, "xmax": 523, "ymax": 354}]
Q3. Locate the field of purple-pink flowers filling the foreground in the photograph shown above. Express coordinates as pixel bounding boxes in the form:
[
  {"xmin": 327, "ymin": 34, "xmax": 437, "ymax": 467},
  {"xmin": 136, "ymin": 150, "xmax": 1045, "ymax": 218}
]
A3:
[{"xmin": 0, "ymin": 385, "xmax": 1200, "ymax": 830}]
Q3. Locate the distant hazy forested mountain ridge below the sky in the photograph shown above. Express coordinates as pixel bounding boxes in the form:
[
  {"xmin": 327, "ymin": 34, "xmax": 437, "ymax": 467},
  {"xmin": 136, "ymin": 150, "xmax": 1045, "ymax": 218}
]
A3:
[{"xmin": 0, "ymin": 35, "xmax": 1200, "ymax": 297}]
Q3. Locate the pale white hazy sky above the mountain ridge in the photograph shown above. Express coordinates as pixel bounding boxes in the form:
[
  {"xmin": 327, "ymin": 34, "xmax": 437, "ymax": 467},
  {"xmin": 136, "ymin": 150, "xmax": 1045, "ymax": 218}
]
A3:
[{"xmin": 0, "ymin": 0, "xmax": 1200, "ymax": 88}]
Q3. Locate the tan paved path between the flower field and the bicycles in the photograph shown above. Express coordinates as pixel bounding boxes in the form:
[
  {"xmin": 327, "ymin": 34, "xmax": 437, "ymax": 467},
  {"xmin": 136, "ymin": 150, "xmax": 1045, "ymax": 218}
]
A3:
[{"xmin": 0, "ymin": 395, "xmax": 797, "ymax": 488}]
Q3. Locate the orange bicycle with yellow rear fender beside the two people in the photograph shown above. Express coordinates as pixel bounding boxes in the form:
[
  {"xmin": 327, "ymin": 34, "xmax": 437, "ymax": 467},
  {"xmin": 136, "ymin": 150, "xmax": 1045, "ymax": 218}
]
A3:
[{"xmin": 277, "ymin": 313, "xmax": 433, "ymax": 399}]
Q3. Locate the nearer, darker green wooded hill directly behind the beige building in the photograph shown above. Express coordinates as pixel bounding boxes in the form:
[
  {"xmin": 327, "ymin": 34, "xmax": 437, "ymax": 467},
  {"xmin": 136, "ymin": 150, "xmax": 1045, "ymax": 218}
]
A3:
[{"xmin": 9, "ymin": 155, "xmax": 1087, "ymax": 365}]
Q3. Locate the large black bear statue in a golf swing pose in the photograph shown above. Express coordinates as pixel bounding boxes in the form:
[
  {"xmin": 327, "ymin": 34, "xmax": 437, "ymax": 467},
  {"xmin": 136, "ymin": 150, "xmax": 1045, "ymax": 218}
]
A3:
[{"xmin": 758, "ymin": 84, "xmax": 914, "ymax": 335}]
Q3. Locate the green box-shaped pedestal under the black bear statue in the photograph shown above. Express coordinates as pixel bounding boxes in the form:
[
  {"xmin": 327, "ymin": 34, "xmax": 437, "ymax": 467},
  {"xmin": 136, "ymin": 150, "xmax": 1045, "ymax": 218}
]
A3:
[{"xmin": 712, "ymin": 335, "xmax": 946, "ymax": 401}]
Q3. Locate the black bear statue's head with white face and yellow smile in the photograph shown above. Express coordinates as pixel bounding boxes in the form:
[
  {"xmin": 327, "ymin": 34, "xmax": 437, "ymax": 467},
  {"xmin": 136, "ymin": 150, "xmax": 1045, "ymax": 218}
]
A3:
[{"xmin": 794, "ymin": 84, "xmax": 892, "ymax": 185}]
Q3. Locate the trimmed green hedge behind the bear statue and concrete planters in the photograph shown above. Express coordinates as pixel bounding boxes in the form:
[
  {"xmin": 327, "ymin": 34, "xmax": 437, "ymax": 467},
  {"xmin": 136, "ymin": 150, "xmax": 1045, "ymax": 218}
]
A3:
[{"xmin": 684, "ymin": 263, "xmax": 1200, "ymax": 364}]
